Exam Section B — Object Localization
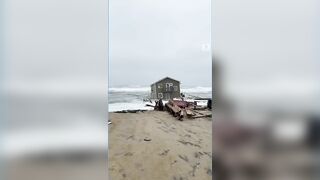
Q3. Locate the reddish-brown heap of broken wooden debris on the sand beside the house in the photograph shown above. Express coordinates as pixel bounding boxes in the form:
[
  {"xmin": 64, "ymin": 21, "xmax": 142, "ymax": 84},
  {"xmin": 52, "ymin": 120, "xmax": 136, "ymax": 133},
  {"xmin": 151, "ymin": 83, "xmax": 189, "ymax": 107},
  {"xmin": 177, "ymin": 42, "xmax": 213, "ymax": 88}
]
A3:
[{"xmin": 165, "ymin": 100, "xmax": 212, "ymax": 121}]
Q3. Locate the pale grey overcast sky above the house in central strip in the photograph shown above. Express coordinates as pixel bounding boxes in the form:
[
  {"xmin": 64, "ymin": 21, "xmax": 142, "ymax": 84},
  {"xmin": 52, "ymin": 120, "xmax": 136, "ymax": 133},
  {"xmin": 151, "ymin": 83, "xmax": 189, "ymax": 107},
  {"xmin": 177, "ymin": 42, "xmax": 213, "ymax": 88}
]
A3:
[{"xmin": 109, "ymin": 0, "xmax": 212, "ymax": 86}]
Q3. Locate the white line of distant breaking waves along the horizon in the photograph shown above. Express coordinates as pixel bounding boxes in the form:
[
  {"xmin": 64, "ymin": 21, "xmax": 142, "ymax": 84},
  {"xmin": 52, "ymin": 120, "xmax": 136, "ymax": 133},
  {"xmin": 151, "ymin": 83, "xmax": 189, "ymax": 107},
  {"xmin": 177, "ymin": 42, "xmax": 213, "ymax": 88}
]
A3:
[{"xmin": 109, "ymin": 86, "xmax": 212, "ymax": 93}]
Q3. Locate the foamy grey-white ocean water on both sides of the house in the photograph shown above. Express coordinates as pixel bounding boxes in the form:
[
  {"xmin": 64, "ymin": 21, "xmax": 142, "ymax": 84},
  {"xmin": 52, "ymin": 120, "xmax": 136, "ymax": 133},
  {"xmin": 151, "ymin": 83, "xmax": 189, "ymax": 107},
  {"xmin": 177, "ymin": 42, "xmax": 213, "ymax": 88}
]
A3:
[{"xmin": 108, "ymin": 87, "xmax": 212, "ymax": 112}]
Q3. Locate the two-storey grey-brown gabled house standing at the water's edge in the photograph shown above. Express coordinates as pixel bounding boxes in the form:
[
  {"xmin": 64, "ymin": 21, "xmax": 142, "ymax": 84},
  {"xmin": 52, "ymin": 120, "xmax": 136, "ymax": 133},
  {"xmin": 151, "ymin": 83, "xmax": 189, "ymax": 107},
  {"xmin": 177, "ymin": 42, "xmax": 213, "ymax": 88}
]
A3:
[{"xmin": 151, "ymin": 77, "xmax": 180, "ymax": 100}]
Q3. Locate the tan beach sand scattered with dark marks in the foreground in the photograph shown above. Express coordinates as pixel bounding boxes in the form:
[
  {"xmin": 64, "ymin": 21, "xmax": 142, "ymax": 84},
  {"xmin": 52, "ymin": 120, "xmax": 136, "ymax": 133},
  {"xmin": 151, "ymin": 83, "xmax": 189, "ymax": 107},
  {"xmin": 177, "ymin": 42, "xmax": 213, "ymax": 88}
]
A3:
[{"xmin": 108, "ymin": 111, "xmax": 212, "ymax": 180}]
